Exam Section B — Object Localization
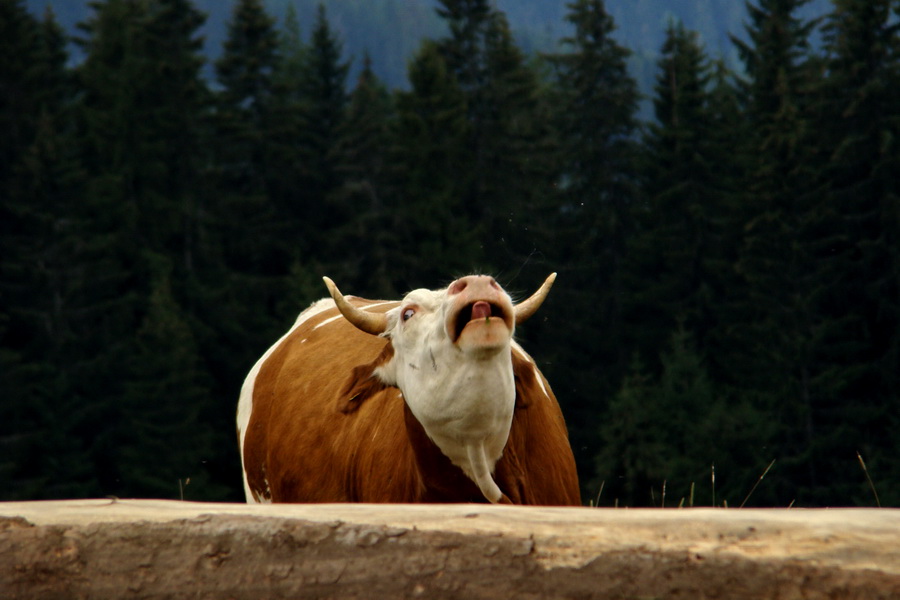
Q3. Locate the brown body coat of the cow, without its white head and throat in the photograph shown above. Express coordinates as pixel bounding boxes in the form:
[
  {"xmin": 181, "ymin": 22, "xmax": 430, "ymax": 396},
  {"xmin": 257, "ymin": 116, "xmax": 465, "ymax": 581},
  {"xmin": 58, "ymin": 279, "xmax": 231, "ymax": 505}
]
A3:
[{"xmin": 243, "ymin": 299, "xmax": 579, "ymax": 505}]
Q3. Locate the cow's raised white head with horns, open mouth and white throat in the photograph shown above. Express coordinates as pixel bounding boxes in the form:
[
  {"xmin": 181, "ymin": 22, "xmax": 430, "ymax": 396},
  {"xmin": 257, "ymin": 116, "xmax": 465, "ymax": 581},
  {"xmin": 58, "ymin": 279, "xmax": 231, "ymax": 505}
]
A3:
[{"xmin": 325, "ymin": 273, "xmax": 556, "ymax": 502}]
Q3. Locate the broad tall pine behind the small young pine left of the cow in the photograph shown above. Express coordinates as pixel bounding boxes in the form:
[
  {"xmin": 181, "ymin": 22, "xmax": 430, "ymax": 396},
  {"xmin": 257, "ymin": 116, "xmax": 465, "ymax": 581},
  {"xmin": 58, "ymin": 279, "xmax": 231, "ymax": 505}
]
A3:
[{"xmin": 69, "ymin": 0, "xmax": 220, "ymax": 490}]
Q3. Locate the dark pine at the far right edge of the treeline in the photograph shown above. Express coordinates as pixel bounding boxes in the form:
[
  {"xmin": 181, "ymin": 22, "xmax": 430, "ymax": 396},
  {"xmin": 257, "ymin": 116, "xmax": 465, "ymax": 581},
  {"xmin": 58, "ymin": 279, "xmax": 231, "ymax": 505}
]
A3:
[{"xmin": 813, "ymin": 0, "xmax": 900, "ymax": 503}]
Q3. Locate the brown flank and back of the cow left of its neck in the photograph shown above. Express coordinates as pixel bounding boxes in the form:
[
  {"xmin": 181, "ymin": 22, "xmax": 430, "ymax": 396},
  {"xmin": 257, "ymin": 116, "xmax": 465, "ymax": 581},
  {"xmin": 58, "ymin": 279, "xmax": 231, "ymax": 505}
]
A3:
[{"xmin": 242, "ymin": 301, "xmax": 417, "ymax": 502}]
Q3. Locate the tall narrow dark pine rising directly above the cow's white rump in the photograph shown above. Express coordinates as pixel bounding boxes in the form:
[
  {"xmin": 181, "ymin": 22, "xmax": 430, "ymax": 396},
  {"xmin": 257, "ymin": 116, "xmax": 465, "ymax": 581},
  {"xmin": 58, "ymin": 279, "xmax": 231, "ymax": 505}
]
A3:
[{"xmin": 211, "ymin": 0, "xmax": 288, "ymax": 328}]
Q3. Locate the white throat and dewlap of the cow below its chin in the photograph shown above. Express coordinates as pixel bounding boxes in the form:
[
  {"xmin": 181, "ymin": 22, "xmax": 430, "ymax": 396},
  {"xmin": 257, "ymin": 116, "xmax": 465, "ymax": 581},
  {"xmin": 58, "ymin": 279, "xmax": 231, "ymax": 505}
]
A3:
[{"xmin": 401, "ymin": 348, "xmax": 516, "ymax": 502}]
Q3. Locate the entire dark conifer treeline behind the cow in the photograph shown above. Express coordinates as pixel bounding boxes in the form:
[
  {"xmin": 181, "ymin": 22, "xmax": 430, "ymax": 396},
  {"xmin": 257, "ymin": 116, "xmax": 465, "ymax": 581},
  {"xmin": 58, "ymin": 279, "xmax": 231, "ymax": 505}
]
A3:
[{"xmin": 0, "ymin": 0, "xmax": 900, "ymax": 506}]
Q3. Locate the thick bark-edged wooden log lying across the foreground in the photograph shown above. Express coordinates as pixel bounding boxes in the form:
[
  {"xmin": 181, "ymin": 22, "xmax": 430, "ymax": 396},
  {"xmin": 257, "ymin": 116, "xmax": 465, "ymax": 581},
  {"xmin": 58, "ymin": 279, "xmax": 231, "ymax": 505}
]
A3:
[{"xmin": 0, "ymin": 500, "xmax": 900, "ymax": 600}]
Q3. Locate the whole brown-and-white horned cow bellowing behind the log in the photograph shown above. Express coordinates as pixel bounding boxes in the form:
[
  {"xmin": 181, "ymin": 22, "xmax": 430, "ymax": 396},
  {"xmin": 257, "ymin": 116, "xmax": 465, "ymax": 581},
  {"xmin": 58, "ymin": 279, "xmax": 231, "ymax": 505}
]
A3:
[{"xmin": 237, "ymin": 273, "xmax": 580, "ymax": 505}]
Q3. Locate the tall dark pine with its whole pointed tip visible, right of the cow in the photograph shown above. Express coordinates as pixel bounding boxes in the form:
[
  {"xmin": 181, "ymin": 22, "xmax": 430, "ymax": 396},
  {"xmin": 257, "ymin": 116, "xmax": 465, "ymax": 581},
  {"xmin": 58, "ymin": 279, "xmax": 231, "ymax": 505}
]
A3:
[{"xmin": 626, "ymin": 23, "xmax": 746, "ymax": 398}]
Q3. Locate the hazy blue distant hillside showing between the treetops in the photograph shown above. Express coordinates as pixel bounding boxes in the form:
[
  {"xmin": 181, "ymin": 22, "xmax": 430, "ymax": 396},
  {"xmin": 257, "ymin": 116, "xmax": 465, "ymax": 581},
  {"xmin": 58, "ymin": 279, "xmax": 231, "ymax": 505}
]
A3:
[{"xmin": 27, "ymin": 0, "xmax": 831, "ymax": 108}]
